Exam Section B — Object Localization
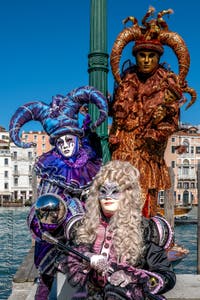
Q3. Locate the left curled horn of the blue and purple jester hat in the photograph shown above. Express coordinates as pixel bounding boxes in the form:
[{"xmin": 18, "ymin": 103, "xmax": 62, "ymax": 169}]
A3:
[{"xmin": 9, "ymin": 102, "xmax": 49, "ymax": 148}]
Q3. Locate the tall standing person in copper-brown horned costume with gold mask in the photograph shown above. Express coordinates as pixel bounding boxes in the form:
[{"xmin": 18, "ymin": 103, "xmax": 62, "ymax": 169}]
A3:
[{"xmin": 109, "ymin": 7, "xmax": 196, "ymax": 216}]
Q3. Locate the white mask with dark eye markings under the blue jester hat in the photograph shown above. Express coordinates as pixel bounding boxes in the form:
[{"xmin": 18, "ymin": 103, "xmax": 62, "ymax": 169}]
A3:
[{"xmin": 56, "ymin": 134, "xmax": 78, "ymax": 158}]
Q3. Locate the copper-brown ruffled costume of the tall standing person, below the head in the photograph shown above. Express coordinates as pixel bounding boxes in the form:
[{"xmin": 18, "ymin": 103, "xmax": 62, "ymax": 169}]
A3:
[{"xmin": 110, "ymin": 66, "xmax": 179, "ymax": 197}]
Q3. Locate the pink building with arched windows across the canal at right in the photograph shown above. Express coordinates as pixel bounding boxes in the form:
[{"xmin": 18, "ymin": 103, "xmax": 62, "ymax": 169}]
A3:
[{"xmin": 164, "ymin": 124, "xmax": 200, "ymax": 206}]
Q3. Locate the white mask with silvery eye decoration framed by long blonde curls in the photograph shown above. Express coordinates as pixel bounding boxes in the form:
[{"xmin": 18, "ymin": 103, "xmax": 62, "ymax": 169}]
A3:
[{"xmin": 99, "ymin": 181, "xmax": 122, "ymax": 216}]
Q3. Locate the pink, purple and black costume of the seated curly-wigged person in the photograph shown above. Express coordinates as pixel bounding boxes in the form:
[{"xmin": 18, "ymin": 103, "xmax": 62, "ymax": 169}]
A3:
[{"xmin": 60, "ymin": 217, "xmax": 176, "ymax": 300}]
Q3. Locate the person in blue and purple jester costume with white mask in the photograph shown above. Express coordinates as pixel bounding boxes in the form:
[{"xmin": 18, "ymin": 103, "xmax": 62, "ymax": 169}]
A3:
[{"xmin": 9, "ymin": 86, "xmax": 107, "ymax": 300}]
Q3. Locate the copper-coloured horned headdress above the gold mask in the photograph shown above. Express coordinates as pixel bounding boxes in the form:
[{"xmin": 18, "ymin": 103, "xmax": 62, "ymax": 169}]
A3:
[{"xmin": 110, "ymin": 7, "xmax": 197, "ymax": 109}]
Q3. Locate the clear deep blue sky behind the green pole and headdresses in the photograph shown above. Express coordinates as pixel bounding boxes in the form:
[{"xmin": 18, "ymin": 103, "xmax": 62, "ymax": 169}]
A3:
[{"xmin": 0, "ymin": 0, "xmax": 200, "ymax": 130}]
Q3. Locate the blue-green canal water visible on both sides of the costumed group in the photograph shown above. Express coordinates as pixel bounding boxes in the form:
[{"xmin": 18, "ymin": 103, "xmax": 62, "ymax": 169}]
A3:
[{"xmin": 0, "ymin": 207, "xmax": 197, "ymax": 300}]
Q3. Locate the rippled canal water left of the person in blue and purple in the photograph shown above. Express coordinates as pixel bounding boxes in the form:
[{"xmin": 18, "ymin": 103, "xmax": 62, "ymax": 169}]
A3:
[{"xmin": 0, "ymin": 207, "xmax": 31, "ymax": 300}]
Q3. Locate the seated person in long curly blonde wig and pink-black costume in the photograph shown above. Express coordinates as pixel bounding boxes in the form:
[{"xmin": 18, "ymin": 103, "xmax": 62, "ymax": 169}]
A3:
[{"xmin": 59, "ymin": 160, "xmax": 176, "ymax": 300}]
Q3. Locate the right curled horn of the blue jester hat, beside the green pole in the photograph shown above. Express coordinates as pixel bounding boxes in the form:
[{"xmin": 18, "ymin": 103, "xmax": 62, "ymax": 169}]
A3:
[{"xmin": 66, "ymin": 86, "xmax": 108, "ymax": 129}]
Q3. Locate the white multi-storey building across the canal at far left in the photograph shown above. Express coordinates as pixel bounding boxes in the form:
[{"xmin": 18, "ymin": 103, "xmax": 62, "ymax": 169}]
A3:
[{"xmin": 0, "ymin": 127, "xmax": 35, "ymax": 205}]
